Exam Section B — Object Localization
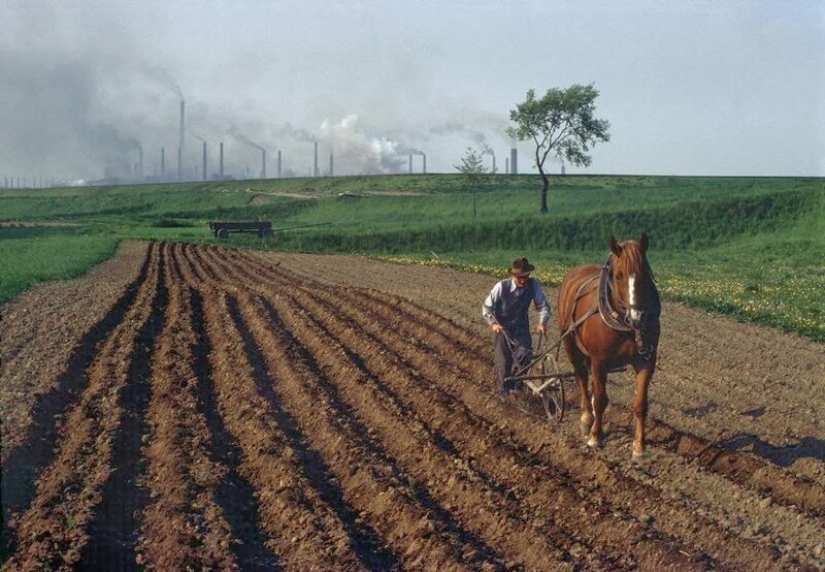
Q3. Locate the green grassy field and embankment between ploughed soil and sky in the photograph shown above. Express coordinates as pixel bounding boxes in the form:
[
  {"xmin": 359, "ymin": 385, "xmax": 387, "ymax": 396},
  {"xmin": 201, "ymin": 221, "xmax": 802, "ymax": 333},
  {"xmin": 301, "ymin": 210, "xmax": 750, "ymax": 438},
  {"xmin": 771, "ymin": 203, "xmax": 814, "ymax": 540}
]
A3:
[{"xmin": 0, "ymin": 175, "xmax": 825, "ymax": 341}]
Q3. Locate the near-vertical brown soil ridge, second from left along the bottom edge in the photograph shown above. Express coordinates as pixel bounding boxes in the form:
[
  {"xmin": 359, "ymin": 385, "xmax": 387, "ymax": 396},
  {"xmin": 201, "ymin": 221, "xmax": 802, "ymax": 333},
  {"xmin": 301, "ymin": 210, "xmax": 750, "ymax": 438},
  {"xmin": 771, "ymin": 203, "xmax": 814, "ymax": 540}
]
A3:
[{"xmin": 137, "ymin": 245, "xmax": 238, "ymax": 570}]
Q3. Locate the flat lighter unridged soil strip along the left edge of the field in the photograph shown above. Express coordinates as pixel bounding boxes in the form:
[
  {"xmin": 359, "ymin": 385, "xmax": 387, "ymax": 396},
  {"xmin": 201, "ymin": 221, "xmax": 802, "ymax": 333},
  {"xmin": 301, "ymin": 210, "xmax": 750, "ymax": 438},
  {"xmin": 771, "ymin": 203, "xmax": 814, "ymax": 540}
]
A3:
[{"xmin": 0, "ymin": 241, "xmax": 148, "ymax": 460}]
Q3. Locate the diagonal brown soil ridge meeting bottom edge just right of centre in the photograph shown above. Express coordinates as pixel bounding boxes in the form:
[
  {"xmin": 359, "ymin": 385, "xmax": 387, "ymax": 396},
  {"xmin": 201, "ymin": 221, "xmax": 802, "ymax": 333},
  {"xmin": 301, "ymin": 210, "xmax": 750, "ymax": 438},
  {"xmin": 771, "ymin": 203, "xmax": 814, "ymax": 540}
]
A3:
[{"xmin": 237, "ymin": 296, "xmax": 501, "ymax": 569}]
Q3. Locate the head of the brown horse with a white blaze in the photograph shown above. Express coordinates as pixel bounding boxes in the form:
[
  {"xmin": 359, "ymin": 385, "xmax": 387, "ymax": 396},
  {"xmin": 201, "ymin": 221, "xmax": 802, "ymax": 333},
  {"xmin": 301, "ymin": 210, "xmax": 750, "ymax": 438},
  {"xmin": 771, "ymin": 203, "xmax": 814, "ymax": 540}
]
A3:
[{"xmin": 610, "ymin": 233, "xmax": 660, "ymax": 330}]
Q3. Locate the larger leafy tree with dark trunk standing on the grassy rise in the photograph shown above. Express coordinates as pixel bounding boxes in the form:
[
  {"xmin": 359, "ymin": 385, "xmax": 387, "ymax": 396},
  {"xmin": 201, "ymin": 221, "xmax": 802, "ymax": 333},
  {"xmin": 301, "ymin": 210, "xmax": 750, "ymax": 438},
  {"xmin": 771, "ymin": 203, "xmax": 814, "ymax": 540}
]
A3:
[{"xmin": 507, "ymin": 84, "xmax": 610, "ymax": 213}]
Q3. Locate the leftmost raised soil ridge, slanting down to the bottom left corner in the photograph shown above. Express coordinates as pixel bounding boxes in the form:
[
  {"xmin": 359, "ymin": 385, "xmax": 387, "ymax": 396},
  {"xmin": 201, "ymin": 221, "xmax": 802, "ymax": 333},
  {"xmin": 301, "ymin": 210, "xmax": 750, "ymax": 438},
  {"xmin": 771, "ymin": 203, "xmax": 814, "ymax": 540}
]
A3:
[{"xmin": 4, "ymin": 241, "xmax": 161, "ymax": 568}]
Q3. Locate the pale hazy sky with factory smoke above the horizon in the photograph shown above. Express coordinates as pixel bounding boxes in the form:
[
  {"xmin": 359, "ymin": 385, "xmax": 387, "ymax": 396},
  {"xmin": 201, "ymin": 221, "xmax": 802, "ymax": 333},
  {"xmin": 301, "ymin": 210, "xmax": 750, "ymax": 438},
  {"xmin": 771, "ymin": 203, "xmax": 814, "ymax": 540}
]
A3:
[{"xmin": 0, "ymin": 0, "xmax": 825, "ymax": 184}]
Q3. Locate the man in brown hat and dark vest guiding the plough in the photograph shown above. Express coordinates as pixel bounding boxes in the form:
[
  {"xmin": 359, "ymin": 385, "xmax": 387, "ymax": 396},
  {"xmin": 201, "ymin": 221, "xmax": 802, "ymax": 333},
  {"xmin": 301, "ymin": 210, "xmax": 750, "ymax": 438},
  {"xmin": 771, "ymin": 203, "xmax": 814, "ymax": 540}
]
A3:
[{"xmin": 481, "ymin": 258, "xmax": 550, "ymax": 396}]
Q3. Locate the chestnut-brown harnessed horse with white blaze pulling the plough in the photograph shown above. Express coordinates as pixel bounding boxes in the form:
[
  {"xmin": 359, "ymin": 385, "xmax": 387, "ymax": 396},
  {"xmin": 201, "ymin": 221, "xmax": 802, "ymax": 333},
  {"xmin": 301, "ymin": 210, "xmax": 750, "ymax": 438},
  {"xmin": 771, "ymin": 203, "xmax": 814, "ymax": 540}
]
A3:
[{"xmin": 558, "ymin": 234, "xmax": 661, "ymax": 459}]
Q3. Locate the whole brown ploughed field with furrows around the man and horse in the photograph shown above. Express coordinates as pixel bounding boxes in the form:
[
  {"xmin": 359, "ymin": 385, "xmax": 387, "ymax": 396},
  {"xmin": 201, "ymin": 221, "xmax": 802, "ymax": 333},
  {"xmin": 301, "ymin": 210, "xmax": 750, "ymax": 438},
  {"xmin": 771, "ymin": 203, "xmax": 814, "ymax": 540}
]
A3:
[{"xmin": 0, "ymin": 243, "xmax": 825, "ymax": 570}]
